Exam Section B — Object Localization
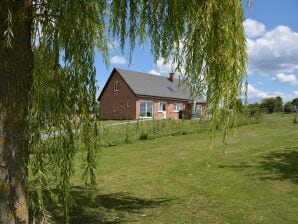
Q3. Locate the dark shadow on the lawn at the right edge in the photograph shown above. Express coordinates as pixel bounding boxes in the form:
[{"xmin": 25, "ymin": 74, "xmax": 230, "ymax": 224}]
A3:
[{"xmin": 260, "ymin": 147, "xmax": 298, "ymax": 183}]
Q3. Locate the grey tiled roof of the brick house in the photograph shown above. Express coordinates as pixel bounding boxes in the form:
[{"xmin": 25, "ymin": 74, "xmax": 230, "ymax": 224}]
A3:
[{"xmin": 99, "ymin": 68, "xmax": 205, "ymax": 102}]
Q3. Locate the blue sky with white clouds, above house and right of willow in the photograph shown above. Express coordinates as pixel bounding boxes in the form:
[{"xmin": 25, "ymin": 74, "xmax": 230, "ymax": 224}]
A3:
[{"xmin": 95, "ymin": 0, "xmax": 298, "ymax": 103}]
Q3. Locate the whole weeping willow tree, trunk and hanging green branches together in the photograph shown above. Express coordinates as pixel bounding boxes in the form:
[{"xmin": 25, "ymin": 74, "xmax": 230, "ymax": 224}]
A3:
[{"xmin": 0, "ymin": 0, "xmax": 246, "ymax": 223}]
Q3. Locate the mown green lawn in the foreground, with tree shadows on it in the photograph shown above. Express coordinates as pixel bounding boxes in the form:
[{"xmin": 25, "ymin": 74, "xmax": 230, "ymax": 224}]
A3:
[{"xmin": 58, "ymin": 115, "xmax": 298, "ymax": 224}]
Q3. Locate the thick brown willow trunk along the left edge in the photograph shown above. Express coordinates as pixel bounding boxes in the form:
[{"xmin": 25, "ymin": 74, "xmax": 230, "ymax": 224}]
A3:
[{"xmin": 0, "ymin": 0, "xmax": 33, "ymax": 224}]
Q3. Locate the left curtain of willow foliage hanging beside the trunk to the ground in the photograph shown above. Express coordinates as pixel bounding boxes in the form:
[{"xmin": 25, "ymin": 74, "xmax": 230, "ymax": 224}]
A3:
[{"xmin": 29, "ymin": 1, "xmax": 107, "ymax": 223}]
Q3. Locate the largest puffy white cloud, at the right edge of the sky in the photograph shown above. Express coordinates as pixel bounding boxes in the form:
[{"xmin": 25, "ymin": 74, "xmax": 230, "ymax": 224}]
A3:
[{"xmin": 247, "ymin": 26, "xmax": 298, "ymax": 75}]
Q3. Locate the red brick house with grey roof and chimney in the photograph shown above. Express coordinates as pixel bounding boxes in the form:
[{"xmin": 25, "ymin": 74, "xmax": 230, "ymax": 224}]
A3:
[{"xmin": 98, "ymin": 68, "xmax": 205, "ymax": 119}]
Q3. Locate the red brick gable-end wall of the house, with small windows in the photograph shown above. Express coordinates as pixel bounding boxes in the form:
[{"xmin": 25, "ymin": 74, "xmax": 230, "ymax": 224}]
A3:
[{"xmin": 99, "ymin": 71, "xmax": 136, "ymax": 119}]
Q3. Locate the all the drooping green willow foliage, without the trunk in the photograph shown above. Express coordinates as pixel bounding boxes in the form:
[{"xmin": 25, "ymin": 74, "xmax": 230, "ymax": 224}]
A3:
[{"xmin": 2, "ymin": 0, "xmax": 246, "ymax": 223}]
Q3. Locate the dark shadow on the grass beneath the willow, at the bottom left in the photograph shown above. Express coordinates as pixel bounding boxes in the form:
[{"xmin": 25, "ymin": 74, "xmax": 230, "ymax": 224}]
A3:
[{"xmin": 55, "ymin": 187, "xmax": 173, "ymax": 224}]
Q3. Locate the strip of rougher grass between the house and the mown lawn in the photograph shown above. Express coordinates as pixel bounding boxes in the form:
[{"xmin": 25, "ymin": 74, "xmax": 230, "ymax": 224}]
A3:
[{"xmin": 99, "ymin": 116, "xmax": 260, "ymax": 147}]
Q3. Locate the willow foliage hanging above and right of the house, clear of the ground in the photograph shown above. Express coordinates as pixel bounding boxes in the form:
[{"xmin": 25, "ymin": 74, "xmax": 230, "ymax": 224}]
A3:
[{"xmin": 110, "ymin": 0, "xmax": 247, "ymax": 144}]
